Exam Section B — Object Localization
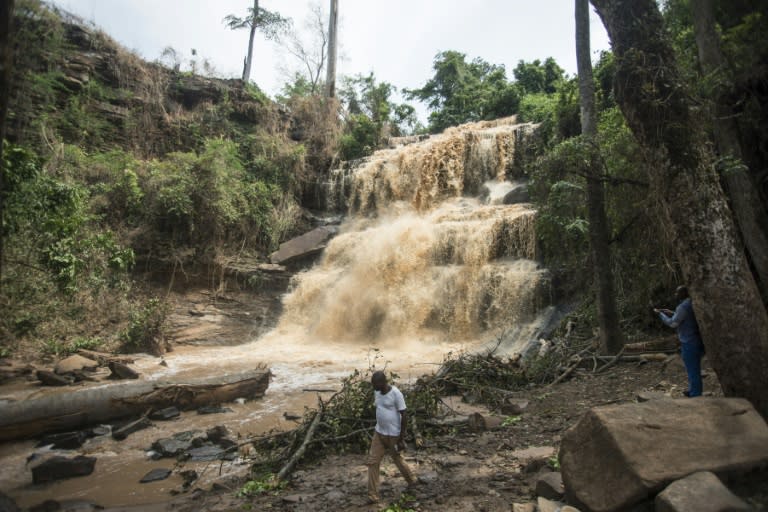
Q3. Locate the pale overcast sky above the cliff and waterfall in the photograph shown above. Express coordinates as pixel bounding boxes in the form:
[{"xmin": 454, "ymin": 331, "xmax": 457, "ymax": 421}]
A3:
[{"xmin": 54, "ymin": 0, "xmax": 609, "ymax": 116}]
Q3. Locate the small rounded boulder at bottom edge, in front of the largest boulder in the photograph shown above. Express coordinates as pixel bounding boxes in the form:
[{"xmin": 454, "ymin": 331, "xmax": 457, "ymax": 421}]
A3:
[{"xmin": 655, "ymin": 471, "xmax": 753, "ymax": 512}]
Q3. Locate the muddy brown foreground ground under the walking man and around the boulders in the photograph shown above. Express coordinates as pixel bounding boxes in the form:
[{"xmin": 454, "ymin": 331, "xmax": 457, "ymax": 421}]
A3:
[{"xmin": 169, "ymin": 356, "xmax": 768, "ymax": 512}]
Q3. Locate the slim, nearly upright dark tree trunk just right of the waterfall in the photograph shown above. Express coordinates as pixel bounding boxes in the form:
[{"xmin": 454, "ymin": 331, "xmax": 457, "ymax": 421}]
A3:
[{"xmin": 576, "ymin": 0, "xmax": 624, "ymax": 354}]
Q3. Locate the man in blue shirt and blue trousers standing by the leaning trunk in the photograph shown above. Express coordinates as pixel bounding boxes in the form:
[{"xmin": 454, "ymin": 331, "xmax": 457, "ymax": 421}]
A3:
[{"xmin": 654, "ymin": 286, "xmax": 704, "ymax": 397}]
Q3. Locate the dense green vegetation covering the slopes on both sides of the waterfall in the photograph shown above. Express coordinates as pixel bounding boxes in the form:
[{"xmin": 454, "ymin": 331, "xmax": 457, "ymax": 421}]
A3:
[{"xmin": 0, "ymin": 0, "xmax": 768, "ymax": 366}]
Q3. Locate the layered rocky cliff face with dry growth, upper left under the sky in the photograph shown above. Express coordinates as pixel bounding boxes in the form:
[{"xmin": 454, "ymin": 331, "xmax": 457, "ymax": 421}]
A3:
[{"xmin": 8, "ymin": 0, "xmax": 286, "ymax": 157}]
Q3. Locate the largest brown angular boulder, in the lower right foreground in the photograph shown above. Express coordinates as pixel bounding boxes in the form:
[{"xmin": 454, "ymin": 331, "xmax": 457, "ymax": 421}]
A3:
[{"xmin": 560, "ymin": 398, "xmax": 768, "ymax": 512}]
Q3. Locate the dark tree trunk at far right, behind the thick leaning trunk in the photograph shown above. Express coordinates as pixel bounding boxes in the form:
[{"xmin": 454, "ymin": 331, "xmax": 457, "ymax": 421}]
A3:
[{"xmin": 691, "ymin": 0, "xmax": 768, "ymax": 303}]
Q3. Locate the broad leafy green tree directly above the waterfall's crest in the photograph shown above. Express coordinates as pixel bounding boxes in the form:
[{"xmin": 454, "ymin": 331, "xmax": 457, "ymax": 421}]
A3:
[{"xmin": 405, "ymin": 51, "xmax": 520, "ymax": 133}]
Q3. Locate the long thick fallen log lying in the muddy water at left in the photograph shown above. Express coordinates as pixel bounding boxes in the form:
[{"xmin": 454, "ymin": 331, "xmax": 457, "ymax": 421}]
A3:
[{"xmin": 0, "ymin": 367, "xmax": 271, "ymax": 441}]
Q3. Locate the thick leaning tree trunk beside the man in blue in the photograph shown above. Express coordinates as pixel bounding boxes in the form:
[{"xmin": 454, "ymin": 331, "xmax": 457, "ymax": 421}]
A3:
[{"xmin": 592, "ymin": 0, "xmax": 768, "ymax": 417}]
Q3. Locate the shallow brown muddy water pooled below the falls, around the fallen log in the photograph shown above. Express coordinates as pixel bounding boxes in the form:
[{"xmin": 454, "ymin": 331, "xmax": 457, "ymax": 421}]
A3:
[{"xmin": 0, "ymin": 329, "xmax": 476, "ymax": 508}]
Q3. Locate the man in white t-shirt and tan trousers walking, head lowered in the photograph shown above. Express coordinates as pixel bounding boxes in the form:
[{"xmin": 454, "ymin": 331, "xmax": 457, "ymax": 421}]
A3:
[{"xmin": 366, "ymin": 372, "xmax": 416, "ymax": 503}]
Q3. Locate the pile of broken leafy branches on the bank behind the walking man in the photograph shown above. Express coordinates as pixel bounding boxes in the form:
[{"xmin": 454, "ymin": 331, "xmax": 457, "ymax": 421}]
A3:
[{"xmin": 242, "ymin": 328, "xmax": 664, "ymax": 481}]
